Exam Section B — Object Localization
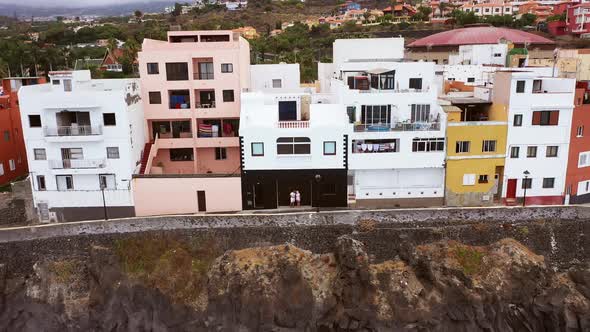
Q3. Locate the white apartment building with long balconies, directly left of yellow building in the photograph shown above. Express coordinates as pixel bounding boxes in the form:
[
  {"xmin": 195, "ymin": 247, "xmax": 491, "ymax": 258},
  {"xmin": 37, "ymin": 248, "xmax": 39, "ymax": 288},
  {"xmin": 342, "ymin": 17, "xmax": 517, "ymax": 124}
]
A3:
[{"xmin": 318, "ymin": 38, "xmax": 446, "ymax": 207}]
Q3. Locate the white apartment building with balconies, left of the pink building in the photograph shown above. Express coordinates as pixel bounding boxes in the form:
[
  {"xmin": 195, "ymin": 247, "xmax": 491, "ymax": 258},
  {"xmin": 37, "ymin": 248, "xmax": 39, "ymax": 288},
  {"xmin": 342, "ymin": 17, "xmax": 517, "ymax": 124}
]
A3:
[{"xmin": 19, "ymin": 70, "xmax": 145, "ymax": 222}]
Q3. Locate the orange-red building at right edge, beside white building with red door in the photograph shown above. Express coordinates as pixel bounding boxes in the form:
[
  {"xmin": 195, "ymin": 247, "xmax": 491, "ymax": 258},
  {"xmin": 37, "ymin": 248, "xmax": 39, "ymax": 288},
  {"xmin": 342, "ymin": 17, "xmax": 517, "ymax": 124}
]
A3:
[{"xmin": 565, "ymin": 82, "xmax": 590, "ymax": 204}]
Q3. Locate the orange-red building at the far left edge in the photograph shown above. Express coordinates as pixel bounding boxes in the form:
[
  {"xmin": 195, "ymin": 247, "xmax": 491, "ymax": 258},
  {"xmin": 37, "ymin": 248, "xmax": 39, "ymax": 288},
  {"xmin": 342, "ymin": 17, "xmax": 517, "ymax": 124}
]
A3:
[{"xmin": 0, "ymin": 77, "xmax": 45, "ymax": 186}]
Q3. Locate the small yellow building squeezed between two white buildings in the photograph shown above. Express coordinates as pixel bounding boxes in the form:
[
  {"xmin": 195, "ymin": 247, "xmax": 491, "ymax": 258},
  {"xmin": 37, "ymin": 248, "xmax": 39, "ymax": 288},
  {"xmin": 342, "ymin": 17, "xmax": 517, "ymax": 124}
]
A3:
[{"xmin": 441, "ymin": 93, "xmax": 508, "ymax": 206}]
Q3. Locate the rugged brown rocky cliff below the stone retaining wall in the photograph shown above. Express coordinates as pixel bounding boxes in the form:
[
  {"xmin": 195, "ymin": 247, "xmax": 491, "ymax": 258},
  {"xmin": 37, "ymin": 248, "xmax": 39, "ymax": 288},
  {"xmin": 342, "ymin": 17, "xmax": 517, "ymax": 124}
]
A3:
[{"xmin": 0, "ymin": 236, "xmax": 590, "ymax": 332}]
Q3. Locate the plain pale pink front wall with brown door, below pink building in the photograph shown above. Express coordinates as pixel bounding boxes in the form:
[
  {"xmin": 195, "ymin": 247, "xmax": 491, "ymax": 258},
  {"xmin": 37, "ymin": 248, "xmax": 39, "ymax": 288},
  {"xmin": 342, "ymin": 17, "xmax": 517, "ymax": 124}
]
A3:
[{"xmin": 133, "ymin": 175, "xmax": 242, "ymax": 216}]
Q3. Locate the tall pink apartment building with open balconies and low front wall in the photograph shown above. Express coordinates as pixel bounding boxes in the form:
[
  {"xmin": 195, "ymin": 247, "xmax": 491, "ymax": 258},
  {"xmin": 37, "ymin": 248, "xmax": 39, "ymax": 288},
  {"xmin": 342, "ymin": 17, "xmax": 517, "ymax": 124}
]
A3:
[{"xmin": 134, "ymin": 31, "xmax": 250, "ymax": 215}]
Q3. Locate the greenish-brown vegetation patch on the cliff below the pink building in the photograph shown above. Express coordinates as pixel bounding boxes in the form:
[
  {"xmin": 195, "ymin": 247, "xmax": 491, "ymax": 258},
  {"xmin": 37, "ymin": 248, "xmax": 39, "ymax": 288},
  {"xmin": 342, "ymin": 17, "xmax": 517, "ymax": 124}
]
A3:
[{"xmin": 115, "ymin": 235, "xmax": 220, "ymax": 303}]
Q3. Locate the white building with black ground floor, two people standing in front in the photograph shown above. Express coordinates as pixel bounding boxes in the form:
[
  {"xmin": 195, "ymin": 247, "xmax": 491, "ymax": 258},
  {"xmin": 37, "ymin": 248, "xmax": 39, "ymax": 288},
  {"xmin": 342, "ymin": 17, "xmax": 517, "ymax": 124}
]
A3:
[{"xmin": 240, "ymin": 64, "xmax": 348, "ymax": 209}]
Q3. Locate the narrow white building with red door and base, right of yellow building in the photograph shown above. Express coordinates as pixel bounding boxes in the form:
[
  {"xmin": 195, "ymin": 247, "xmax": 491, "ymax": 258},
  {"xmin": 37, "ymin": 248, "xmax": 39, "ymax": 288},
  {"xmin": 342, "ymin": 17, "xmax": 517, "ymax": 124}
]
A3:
[{"xmin": 493, "ymin": 71, "xmax": 576, "ymax": 204}]
